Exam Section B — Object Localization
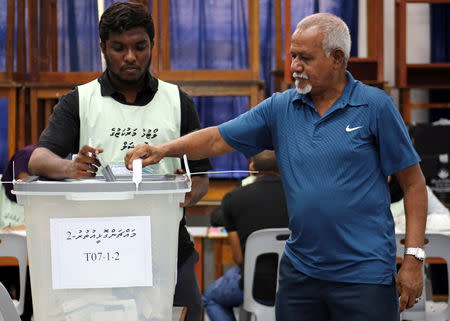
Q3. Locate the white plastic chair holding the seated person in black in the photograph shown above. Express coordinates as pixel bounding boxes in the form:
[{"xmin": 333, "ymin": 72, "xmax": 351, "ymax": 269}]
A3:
[{"xmin": 243, "ymin": 228, "xmax": 291, "ymax": 321}]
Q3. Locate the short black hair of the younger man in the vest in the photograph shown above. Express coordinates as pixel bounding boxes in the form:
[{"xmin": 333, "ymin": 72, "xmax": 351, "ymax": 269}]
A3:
[{"xmin": 98, "ymin": 2, "xmax": 155, "ymax": 43}]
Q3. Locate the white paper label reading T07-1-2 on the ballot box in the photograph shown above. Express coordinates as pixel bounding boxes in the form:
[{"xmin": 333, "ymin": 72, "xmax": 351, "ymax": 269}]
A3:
[{"xmin": 50, "ymin": 216, "xmax": 153, "ymax": 289}]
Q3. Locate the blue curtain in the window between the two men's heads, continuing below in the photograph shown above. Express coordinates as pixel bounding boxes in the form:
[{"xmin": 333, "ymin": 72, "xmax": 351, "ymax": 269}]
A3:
[{"xmin": 170, "ymin": 0, "xmax": 249, "ymax": 178}]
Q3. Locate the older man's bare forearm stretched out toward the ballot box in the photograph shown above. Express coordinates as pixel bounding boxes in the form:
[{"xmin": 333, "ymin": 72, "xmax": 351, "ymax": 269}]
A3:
[{"xmin": 159, "ymin": 126, "xmax": 234, "ymax": 160}]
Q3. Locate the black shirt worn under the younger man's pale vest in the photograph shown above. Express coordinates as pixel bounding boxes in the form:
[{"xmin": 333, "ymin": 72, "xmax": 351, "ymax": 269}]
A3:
[{"xmin": 37, "ymin": 72, "xmax": 212, "ymax": 266}]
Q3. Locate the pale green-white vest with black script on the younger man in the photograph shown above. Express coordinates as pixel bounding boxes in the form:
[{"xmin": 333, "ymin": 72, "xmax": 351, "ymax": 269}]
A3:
[{"xmin": 78, "ymin": 79, "xmax": 181, "ymax": 174}]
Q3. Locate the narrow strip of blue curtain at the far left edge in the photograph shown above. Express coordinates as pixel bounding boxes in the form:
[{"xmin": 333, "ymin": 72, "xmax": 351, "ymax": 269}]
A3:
[{"xmin": 0, "ymin": 0, "xmax": 8, "ymax": 174}]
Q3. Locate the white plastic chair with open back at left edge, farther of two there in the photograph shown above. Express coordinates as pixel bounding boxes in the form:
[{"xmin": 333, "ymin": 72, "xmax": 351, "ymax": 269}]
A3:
[{"xmin": 0, "ymin": 232, "xmax": 28, "ymax": 321}]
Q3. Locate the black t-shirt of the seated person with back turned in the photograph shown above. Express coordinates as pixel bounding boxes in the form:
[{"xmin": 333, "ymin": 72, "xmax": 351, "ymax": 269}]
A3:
[{"xmin": 221, "ymin": 175, "xmax": 289, "ymax": 301}]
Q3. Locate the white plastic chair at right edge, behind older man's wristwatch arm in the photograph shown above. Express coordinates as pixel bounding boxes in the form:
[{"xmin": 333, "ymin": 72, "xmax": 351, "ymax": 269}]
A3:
[{"xmin": 396, "ymin": 234, "xmax": 450, "ymax": 321}]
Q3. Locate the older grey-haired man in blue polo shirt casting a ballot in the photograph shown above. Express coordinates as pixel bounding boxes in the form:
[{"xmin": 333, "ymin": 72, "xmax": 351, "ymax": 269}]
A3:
[{"xmin": 126, "ymin": 13, "xmax": 427, "ymax": 321}]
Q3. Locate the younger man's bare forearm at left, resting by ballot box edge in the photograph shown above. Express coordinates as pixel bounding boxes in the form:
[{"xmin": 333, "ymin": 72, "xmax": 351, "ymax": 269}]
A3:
[{"xmin": 28, "ymin": 147, "xmax": 71, "ymax": 179}]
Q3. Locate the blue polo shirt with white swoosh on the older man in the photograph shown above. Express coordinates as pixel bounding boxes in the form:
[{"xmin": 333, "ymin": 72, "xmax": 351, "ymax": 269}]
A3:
[{"xmin": 219, "ymin": 72, "xmax": 420, "ymax": 284}]
